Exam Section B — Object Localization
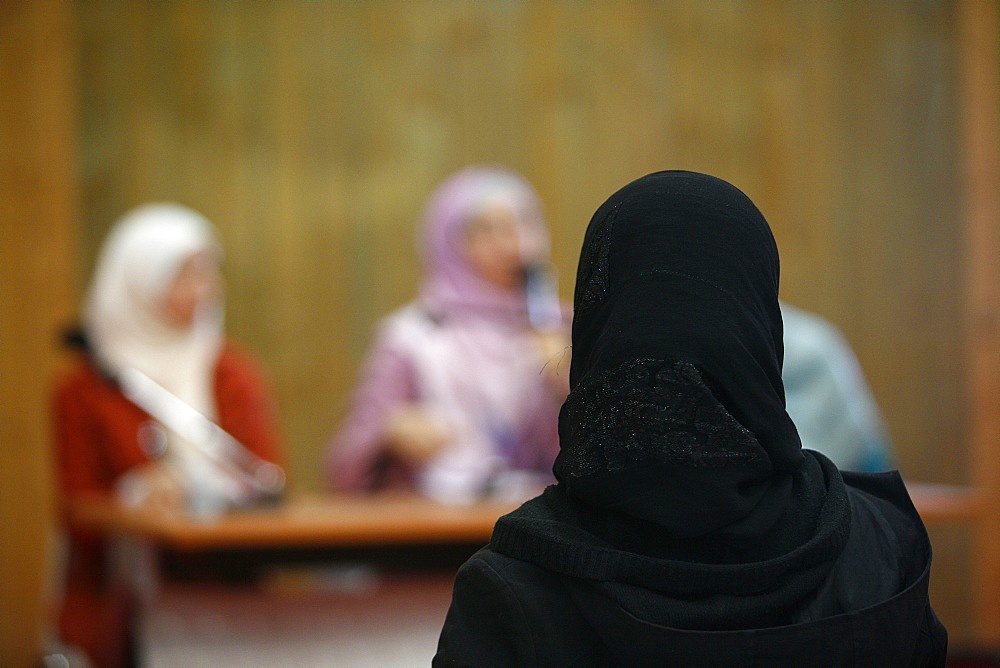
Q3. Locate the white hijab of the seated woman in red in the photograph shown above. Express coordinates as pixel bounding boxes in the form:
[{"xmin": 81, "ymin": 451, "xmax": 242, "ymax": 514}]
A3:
[{"xmin": 84, "ymin": 203, "xmax": 223, "ymax": 418}]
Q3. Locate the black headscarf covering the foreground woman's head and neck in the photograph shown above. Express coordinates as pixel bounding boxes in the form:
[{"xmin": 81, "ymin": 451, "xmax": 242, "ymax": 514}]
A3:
[{"xmin": 554, "ymin": 171, "xmax": 822, "ymax": 544}]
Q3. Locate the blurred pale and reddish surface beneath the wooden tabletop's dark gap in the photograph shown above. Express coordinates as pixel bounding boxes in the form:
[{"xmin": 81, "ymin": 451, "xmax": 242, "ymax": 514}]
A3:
[{"xmin": 139, "ymin": 566, "xmax": 454, "ymax": 668}]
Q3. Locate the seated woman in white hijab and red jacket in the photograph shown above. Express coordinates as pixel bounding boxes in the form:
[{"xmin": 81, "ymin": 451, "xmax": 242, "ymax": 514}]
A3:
[{"xmin": 54, "ymin": 204, "xmax": 282, "ymax": 666}]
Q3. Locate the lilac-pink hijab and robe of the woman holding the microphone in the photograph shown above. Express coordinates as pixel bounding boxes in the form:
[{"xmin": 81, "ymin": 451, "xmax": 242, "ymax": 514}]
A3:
[{"xmin": 326, "ymin": 167, "xmax": 568, "ymax": 500}]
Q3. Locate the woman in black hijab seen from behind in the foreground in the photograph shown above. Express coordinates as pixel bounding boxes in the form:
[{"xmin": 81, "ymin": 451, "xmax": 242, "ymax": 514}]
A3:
[{"xmin": 434, "ymin": 171, "xmax": 947, "ymax": 666}]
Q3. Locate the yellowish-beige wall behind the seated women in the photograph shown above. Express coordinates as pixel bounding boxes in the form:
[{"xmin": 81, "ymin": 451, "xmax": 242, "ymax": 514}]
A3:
[{"xmin": 0, "ymin": 0, "xmax": 992, "ymax": 656}]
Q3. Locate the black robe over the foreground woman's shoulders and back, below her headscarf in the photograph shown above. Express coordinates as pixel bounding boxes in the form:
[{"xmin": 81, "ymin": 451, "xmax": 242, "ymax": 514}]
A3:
[{"xmin": 434, "ymin": 462, "xmax": 947, "ymax": 666}]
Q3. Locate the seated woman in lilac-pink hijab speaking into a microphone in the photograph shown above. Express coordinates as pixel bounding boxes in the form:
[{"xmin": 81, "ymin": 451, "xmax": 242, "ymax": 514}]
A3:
[{"xmin": 326, "ymin": 167, "xmax": 569, "ymax": 503}]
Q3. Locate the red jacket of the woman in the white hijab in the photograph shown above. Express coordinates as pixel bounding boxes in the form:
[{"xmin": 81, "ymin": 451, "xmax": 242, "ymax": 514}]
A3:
[{"xmin": 53, "ymin": 343, "xmax": 283, "ymax": 666}]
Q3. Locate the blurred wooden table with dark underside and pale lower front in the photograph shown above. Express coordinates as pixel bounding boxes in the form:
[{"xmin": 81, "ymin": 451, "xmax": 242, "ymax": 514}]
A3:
[{"xmin": 69, "ymin": 494, "xmax": 500, "ymax": 665}]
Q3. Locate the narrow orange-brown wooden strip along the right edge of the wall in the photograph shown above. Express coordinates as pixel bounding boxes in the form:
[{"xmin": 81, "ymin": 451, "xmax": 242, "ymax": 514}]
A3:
[{"xmin": 957, "ymin": 2, "xmax": 1000, "ymax": 647}]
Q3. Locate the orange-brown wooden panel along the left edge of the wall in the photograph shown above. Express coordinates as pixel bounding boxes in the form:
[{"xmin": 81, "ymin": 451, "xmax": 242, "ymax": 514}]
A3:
[{"xmin": 0, "ymin": 0, "xmax": 78, "ymax": 666}]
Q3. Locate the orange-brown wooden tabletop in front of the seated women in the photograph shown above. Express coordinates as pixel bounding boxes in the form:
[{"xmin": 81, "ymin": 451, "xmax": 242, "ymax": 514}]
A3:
[{"xmin": 70, "ymin": 483, "xmax": 984, "ymax": 551}]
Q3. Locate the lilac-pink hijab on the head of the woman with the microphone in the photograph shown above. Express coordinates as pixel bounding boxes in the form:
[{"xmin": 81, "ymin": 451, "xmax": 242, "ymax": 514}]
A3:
[{"xmin": 420, "ymin": 166, "xmax": 549, "ymax": 319}]
